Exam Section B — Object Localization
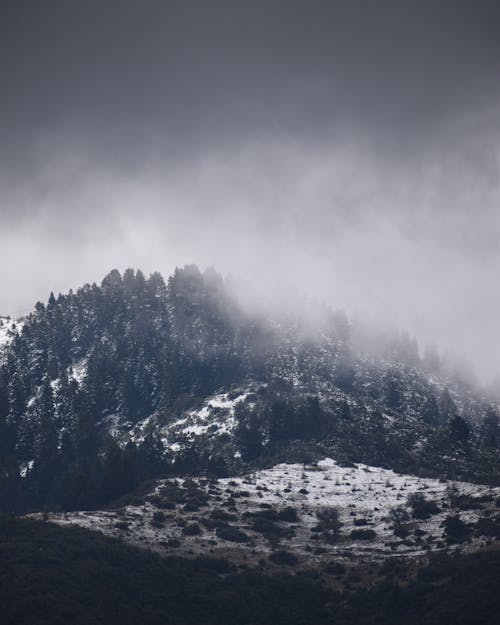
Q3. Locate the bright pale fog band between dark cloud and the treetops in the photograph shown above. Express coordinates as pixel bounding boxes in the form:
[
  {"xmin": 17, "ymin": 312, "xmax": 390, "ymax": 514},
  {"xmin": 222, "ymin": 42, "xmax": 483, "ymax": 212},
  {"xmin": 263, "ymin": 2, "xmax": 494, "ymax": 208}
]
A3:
[{"xmin": 0, "ymin": 132, "xmax": 500, "ymax": 382}]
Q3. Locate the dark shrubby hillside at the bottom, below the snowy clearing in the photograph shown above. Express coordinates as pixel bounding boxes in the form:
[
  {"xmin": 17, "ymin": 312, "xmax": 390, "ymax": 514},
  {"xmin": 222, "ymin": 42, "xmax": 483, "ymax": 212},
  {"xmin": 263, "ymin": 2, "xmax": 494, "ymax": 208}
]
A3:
[{"xmin": 0, "ymin": 518, "xmax": 500, "ymax": 625}]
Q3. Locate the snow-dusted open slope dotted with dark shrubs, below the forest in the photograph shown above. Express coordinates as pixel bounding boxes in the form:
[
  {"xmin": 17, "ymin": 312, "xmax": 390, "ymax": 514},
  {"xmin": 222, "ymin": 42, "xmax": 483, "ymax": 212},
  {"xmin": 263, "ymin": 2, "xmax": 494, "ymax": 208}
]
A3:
[{"xmin": 44, "ymin": 459, "xmax": 500, "ymax": 564}]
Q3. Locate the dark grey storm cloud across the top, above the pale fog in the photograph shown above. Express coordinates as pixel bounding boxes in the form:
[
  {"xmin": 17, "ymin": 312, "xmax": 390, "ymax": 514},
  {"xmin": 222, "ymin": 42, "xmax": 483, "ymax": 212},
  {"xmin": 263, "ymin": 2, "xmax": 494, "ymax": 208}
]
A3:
[{"xmin": 1, "ymin": 0, "xmax": 500, "ymax": 165}]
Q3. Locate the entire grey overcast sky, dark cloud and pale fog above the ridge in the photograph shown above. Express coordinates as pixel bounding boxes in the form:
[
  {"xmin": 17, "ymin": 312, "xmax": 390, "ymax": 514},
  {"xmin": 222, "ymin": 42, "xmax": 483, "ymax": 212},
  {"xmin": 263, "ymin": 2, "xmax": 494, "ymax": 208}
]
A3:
[{"xmin": 0, "ymin": 0, "xmax": 500, "ymax": 379}]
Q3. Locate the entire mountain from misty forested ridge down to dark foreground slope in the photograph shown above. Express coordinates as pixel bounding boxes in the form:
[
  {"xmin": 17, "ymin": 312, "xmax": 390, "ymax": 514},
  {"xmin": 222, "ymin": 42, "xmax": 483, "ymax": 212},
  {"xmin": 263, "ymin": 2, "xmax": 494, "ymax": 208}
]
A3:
[{"xmin": 0, "ymin": 266, "xmax": 500, "ymax": 625}]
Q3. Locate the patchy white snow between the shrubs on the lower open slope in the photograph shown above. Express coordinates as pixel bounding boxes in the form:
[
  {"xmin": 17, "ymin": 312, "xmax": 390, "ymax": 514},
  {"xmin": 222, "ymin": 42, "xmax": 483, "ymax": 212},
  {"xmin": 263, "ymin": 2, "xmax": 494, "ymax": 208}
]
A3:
[{"xmin": 42, "ymin": 458, "xmax": 500, "ymax": 564}]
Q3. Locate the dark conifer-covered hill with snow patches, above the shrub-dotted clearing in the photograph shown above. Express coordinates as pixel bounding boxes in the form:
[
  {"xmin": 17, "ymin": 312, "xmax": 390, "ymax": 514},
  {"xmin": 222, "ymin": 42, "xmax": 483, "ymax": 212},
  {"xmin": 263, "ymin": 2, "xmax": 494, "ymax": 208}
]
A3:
[{"xmin": 0, "ymin": 266, "xmax": 500, "ymax": 513}]
